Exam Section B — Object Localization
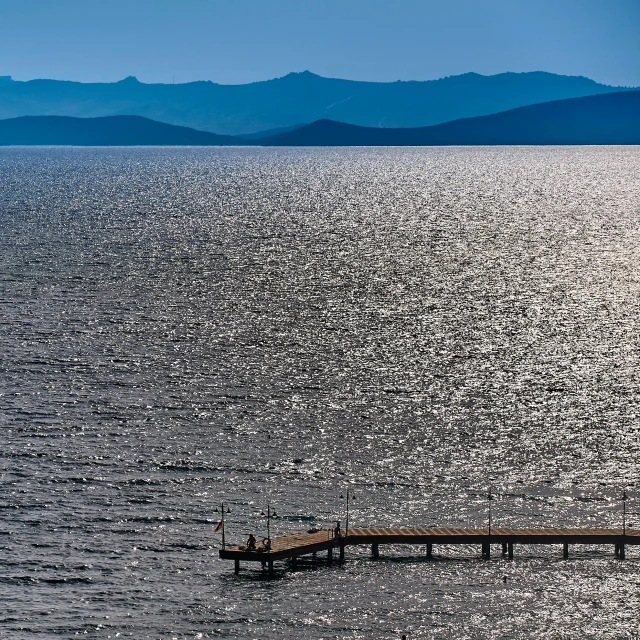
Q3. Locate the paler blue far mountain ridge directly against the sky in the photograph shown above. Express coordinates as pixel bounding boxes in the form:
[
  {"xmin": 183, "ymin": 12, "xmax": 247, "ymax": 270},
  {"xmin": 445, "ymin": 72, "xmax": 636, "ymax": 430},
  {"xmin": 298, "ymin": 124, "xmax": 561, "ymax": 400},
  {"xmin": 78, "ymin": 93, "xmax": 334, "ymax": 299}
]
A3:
[{"xmin": 0, "ymin": 71, "xmax": 632, "ymax": 135}]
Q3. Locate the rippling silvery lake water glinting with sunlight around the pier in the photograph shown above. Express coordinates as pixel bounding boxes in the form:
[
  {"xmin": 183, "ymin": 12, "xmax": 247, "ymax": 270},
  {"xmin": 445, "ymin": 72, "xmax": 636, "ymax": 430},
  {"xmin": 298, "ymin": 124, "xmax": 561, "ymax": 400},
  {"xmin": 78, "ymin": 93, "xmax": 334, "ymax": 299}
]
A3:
[{"xmin": 0, "ymin": 147, "xmax": 640, "ymax": 640}]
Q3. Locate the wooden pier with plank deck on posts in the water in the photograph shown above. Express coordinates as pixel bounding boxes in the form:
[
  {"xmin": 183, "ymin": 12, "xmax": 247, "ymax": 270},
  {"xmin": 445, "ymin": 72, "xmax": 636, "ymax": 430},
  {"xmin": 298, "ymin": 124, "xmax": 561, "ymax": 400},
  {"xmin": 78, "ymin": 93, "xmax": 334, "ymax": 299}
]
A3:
[{"xmin": 220, "ymin": 527, "xmax": 640, "ymax": 576}]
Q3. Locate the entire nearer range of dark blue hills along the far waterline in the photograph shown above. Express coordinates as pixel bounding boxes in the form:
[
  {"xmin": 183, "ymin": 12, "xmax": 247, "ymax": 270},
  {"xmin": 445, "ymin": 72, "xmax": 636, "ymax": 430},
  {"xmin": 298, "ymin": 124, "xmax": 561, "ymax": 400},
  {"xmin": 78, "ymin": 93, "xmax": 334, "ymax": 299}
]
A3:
[{"xmin": 0, "ymin": 91, "xmax": 640, "ymax": 146}]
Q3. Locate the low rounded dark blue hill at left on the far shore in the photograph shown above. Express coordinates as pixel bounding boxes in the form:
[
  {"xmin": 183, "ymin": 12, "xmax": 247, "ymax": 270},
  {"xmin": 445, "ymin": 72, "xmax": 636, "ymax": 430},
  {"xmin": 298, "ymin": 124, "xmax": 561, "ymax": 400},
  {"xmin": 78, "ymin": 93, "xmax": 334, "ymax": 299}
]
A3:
[{"xmin": 0, "ymin": 116, "xmax": 244, "ymax": 146}]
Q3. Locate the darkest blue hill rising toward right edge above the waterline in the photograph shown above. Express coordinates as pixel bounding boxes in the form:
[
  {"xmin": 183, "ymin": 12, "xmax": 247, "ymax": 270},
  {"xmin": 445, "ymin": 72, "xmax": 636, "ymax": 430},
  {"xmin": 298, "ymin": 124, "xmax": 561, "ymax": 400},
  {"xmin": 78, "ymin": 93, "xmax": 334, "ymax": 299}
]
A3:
[{"xmin": 260, "ymin": 91, "xmax": 640, "ymax": 146}]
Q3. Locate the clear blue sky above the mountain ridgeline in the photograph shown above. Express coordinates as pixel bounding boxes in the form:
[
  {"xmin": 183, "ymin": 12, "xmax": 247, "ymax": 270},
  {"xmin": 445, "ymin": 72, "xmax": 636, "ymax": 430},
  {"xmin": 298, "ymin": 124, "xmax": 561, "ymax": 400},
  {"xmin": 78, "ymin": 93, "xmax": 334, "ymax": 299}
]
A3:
[{"xmin": 0, "ymin": 0, "xmax": 640, "ymax": 86}]
